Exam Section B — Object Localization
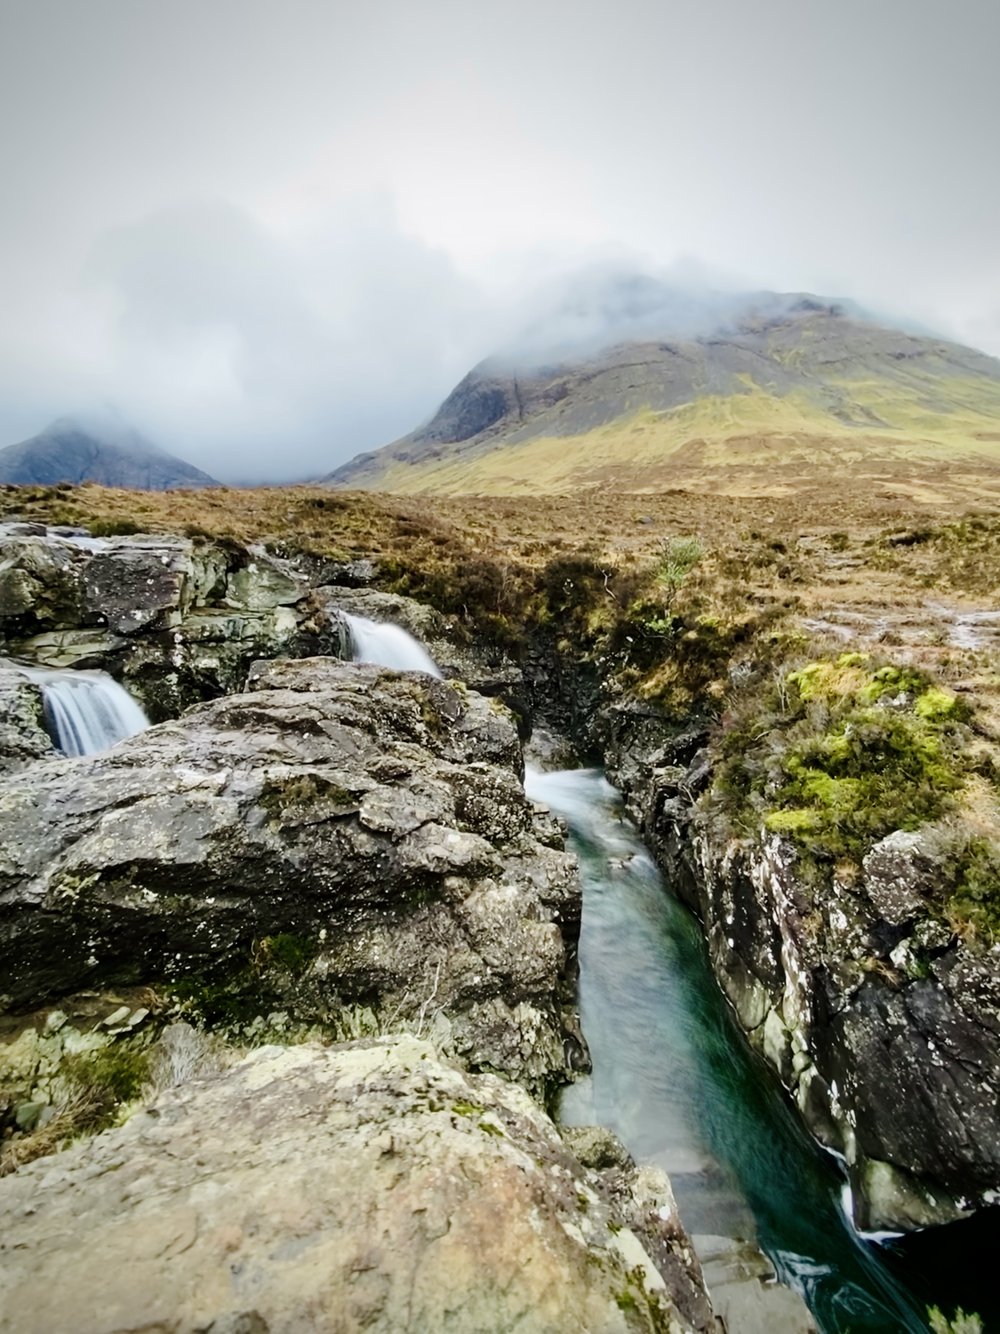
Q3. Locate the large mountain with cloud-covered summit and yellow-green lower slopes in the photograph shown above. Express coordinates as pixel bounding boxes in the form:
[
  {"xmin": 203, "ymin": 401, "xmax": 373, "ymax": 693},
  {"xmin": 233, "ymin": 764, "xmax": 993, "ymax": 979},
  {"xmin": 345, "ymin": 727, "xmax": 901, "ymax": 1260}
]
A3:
[{"xmin": 324, "ymin": 293, "xmax": 1000, "ymax": 495}]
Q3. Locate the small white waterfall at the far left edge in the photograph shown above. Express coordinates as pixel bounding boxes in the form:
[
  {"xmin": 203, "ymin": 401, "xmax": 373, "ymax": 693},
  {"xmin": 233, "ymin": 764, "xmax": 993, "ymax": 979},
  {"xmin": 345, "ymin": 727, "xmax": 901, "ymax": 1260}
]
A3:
[{"xmin": 28, "ymin": 670, "xmax": 149, "ymax": 755}]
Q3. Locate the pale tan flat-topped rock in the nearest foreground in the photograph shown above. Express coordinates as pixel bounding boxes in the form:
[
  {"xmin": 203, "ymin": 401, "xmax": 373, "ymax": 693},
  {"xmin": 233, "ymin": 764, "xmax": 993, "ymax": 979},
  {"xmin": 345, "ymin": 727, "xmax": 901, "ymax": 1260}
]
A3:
[{"xmin": 0, "ymin": 1038, "xmax": 715, "ymax": 1334}]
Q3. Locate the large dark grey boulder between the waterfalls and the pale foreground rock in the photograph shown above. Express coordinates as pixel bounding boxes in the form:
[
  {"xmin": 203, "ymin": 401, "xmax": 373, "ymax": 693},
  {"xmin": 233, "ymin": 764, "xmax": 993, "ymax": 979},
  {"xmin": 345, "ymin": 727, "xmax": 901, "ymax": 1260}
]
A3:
[{"xmin": 0, "ymin": 659, "xmax": 585, "ymax": 1091}]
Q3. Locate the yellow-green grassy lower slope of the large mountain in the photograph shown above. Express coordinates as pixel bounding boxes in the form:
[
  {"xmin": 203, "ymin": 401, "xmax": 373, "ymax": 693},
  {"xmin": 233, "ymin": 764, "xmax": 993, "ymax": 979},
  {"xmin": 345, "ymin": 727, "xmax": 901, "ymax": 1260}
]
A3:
[{"xmin": 370, "ymin": 376, "xmax": 1000, "ymax": 495}]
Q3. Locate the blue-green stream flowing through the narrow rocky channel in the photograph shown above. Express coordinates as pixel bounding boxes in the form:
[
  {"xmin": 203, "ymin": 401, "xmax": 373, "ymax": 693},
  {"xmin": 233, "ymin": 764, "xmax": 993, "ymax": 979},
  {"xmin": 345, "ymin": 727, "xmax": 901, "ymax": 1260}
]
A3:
[{"xmin": 525, "ymin": 770, "xmax": 928, "ymax": 1334}]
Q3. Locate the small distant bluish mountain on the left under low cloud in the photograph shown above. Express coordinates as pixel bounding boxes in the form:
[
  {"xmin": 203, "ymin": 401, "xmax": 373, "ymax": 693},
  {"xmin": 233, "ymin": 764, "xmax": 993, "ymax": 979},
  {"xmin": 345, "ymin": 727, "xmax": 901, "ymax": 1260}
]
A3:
[{"xmin": 0, "ymin": 418, "xmax": 219, "ymax": 491}]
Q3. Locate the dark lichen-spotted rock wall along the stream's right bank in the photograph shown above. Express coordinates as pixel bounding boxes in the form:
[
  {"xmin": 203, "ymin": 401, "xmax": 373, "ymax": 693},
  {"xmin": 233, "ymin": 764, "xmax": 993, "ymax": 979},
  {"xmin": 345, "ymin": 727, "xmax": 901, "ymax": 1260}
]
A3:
[{"xmin": 604, "ymin": 707, "xmax": 1000, "ymax": 1229}]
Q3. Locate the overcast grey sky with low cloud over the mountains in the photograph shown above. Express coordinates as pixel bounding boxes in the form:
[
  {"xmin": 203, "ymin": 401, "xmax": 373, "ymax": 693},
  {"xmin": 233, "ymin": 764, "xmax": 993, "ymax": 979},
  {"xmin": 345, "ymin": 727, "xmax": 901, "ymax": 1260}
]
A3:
[{"xmin": 0, "ymin": 0, "xmax": 1000, "ymax": 482}]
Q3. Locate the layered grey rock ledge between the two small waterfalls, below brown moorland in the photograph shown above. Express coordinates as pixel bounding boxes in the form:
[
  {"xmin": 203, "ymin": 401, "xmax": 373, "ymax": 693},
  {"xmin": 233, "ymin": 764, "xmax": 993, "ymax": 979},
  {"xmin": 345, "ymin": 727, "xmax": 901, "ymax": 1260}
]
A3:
[{"xmin": 0, "ymin": 524, "xmax": 339, "ymax": 719}]
